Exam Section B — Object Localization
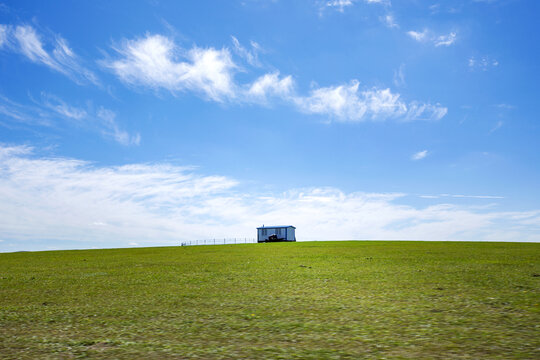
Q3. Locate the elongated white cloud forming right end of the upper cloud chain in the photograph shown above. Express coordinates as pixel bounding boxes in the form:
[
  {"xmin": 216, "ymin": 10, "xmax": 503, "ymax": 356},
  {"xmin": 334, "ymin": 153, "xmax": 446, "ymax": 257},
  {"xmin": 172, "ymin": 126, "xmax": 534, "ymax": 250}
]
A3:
[{"xmin": 295, "ymin": 81, "xmax": 447, "ymax": 121}]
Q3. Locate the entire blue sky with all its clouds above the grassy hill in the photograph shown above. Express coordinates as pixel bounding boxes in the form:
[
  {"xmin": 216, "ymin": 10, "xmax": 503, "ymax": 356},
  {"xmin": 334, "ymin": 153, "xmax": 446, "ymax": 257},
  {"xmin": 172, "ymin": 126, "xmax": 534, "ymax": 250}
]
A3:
[{"xmin": 0, "ymin": 0, "xmax": 540, "ymax": 251}]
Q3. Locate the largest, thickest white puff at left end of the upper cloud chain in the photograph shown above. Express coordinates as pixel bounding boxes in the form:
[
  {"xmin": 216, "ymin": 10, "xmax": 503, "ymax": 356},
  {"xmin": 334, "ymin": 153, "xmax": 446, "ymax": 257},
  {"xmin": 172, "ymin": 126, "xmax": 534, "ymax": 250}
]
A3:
[{"xmin": 105, "ymin": 35, "xmax": 236, "ymax": 102}]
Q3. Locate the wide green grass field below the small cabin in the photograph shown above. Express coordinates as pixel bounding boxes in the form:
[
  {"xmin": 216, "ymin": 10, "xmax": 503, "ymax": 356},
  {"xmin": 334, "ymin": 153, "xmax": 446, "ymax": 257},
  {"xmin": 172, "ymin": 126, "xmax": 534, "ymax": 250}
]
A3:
[{"xmin": 0, "ymin": 241, "xmax": 540, "ymax": 359}]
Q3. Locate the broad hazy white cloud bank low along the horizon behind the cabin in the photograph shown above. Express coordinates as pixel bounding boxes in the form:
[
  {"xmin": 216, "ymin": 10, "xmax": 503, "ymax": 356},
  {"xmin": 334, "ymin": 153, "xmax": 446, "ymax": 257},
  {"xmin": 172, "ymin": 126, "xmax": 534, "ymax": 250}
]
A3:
[{"xmin": 0, "ymin": 146, "xmax": 540, "ymax": 252}]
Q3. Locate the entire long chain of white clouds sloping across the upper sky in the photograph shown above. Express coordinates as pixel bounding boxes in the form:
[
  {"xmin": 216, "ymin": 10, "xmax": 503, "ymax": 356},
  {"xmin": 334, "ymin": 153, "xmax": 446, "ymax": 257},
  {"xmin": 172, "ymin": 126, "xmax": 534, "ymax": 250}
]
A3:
[{"xmin": 104, "ymin": 35, "xmax": 447, "ymax": 121}]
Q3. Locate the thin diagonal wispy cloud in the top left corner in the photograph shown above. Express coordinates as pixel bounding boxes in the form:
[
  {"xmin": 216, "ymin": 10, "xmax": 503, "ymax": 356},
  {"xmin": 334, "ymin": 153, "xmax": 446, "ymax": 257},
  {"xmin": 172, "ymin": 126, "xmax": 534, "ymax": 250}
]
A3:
[{"xmin": 0, "ymin": 25, "xmax": 99, "ymax": 85}]
